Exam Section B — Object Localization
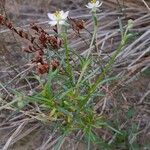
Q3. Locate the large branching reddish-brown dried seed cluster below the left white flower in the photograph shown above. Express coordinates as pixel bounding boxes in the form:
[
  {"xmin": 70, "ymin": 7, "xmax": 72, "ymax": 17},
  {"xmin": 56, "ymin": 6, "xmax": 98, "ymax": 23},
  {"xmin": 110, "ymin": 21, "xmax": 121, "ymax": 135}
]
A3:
[{"xmin": 0, "ymin": 15, "xmax": 62, "ymax": 74}]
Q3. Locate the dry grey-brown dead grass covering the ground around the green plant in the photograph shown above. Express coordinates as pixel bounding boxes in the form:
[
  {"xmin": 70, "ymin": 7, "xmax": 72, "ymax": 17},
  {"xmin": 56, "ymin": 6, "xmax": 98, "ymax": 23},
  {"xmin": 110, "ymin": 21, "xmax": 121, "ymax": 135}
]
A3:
[{"xmin": 0, "ymin": 0, "xmax": 150, "ymax": 150}]
